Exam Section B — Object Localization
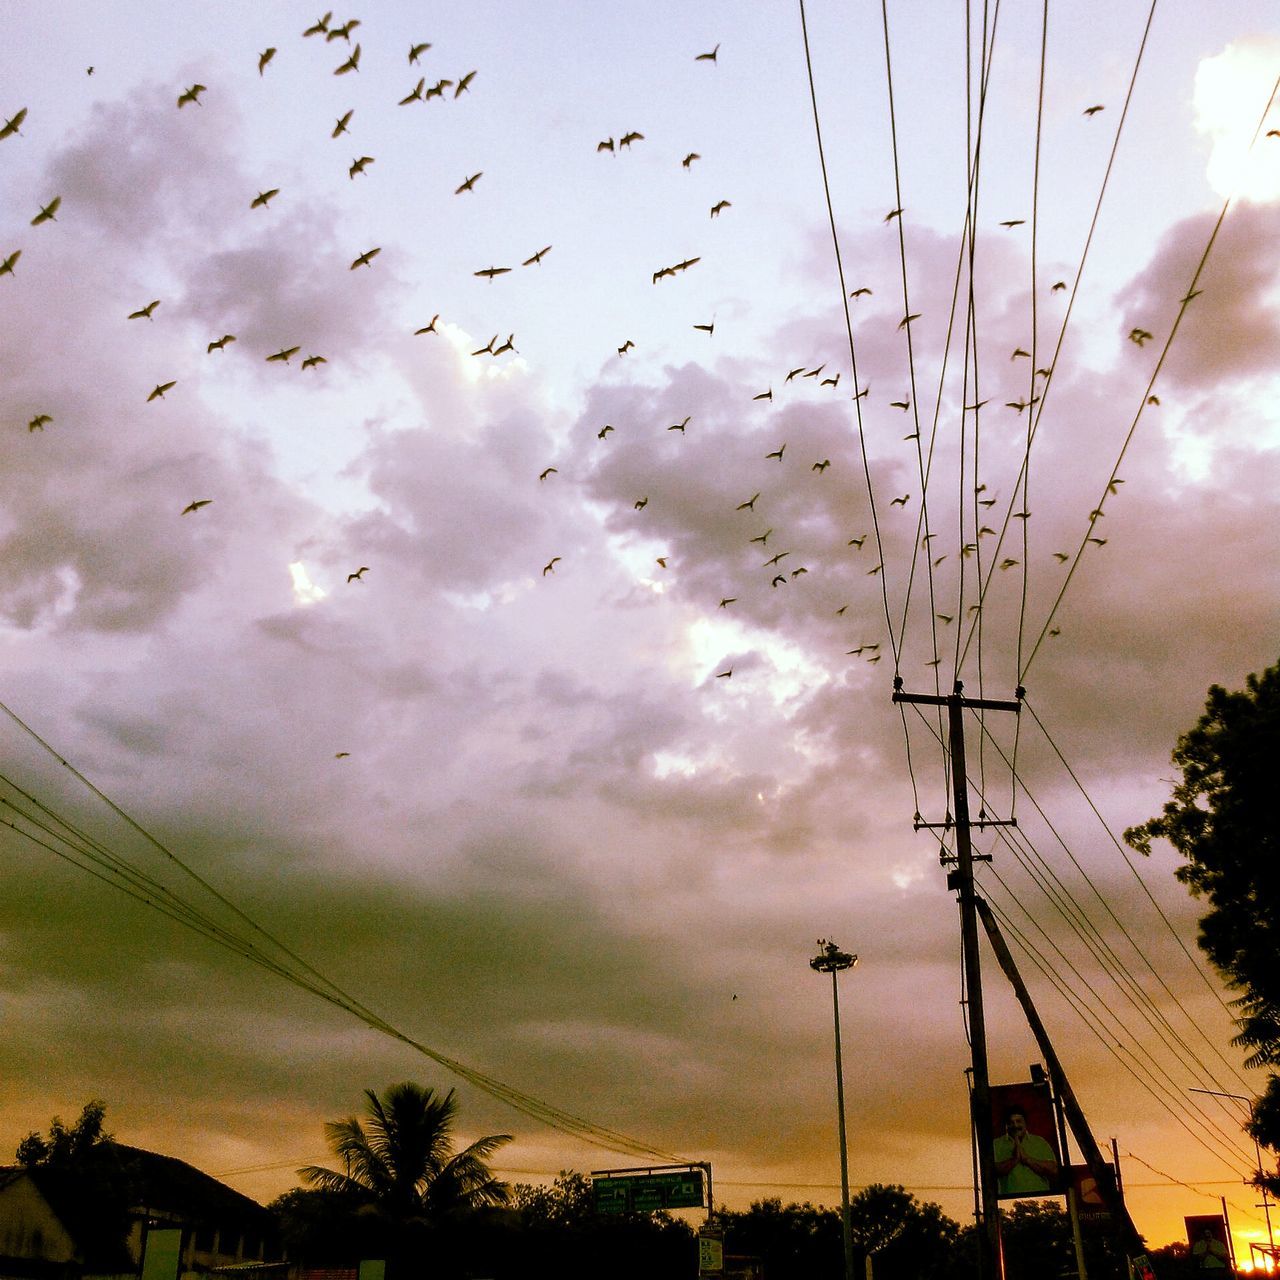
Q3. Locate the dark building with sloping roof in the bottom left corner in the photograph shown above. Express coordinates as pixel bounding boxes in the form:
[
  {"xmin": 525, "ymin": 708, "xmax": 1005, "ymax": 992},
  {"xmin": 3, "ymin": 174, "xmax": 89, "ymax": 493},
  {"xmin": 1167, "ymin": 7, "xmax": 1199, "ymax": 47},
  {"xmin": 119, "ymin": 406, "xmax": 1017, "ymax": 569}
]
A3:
[{"xmin": 0, "ymin": 1142, "xmax": 284, "ymax": 1280}]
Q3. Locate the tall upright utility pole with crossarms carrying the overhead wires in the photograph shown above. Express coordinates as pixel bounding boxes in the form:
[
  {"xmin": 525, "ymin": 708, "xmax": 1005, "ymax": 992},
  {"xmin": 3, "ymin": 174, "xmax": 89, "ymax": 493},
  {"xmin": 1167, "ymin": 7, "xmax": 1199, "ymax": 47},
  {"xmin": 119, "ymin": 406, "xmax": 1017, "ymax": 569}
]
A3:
[{"xmin": 893, "ymin": 676, "xmax": 1023, "ymax": 1280}]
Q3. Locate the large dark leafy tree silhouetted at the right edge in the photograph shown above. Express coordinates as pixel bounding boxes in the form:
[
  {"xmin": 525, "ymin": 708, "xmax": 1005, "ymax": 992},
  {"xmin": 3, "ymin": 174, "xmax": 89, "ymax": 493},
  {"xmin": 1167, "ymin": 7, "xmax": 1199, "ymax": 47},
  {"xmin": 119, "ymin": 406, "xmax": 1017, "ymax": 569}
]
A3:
[{"xmin": 1125, "ymin": 662, "xmax": 1280, "ymax": 1194}]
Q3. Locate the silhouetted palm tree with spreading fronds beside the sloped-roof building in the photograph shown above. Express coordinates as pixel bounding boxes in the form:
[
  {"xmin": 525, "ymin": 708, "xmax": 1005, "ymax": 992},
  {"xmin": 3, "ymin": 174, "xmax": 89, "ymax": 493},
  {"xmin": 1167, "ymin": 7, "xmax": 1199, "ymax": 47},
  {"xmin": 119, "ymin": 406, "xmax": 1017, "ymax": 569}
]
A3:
[{"xmin": 298, "ymin": 1082, "xmax": 511, "ymax": 1221}]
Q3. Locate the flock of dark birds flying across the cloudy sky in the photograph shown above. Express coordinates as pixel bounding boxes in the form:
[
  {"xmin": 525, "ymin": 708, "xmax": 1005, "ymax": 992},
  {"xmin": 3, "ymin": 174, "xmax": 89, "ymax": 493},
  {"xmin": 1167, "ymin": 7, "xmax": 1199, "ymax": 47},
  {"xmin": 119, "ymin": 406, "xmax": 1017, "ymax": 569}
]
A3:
[{"xmin": 0, "ymin": 12, "xmax": 1158, "ymax": 696}]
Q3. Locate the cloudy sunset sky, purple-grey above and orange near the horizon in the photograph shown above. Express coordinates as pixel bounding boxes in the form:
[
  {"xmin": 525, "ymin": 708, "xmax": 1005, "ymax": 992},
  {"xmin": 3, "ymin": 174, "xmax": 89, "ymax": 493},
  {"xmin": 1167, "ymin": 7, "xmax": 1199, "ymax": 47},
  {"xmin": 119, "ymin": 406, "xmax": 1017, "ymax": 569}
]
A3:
[{"xmin": 0, "ymin": 0, "xmax": 1280, "ymax": 1251}]
